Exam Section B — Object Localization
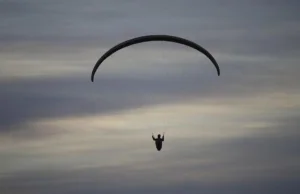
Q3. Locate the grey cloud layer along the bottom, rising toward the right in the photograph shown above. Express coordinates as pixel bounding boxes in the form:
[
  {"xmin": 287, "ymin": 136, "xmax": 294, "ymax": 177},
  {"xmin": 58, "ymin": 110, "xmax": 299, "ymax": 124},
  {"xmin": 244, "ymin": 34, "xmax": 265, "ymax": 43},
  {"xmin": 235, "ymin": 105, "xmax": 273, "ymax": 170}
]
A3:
[{"xmin": 0, "ymin": 115, "xmax": 300, "ymax": 193}]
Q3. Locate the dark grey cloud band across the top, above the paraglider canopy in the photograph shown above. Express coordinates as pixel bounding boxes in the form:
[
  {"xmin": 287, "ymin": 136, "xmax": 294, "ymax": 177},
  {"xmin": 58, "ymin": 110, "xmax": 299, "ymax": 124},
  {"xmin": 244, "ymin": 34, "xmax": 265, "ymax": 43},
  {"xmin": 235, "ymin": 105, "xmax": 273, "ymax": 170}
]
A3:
[{"xmin": 0, "ymin": 0, "xmax": 300, "ymax": 56}]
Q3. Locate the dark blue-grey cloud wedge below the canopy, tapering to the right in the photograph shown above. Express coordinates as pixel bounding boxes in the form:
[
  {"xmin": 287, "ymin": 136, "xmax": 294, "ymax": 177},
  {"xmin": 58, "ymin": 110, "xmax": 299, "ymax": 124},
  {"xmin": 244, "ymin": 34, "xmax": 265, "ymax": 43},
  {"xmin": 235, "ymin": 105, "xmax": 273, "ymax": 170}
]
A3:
[{"xmin": 0, "ymin": 72, "xmax": 219, "ymax": 129}]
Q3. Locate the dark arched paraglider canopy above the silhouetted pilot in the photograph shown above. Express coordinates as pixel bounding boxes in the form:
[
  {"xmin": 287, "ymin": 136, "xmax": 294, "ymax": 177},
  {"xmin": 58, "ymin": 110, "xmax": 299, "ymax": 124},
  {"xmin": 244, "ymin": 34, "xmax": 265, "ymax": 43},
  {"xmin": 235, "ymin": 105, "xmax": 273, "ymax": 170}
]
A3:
[{"xmin": 91, "ymin": 35, "xmax": 220, "ymax": 82}]
